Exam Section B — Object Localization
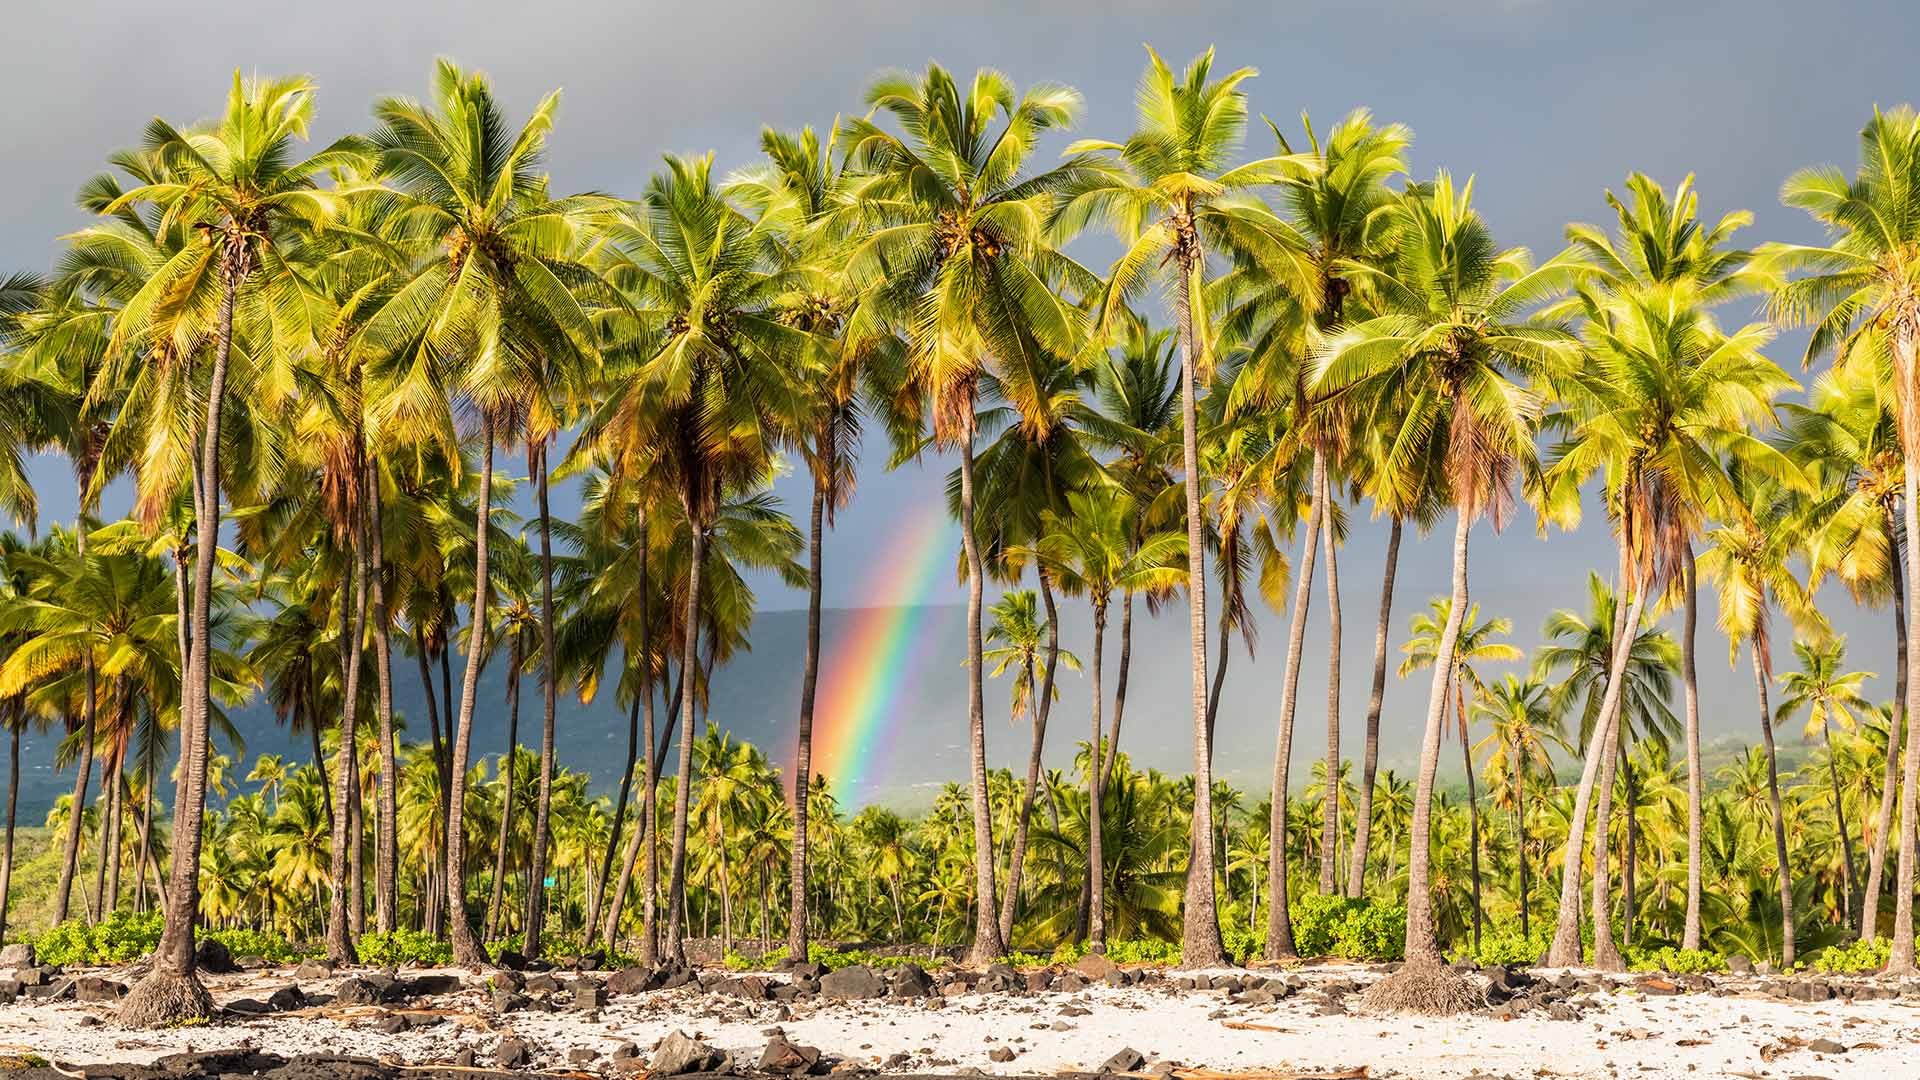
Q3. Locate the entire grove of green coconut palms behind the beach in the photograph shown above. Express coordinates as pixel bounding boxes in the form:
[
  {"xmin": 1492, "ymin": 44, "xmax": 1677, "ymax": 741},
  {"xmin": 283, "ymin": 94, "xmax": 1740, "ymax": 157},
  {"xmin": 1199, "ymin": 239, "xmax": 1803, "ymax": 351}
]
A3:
[{"xmin": 0, "ymin": 52, "xmax": 1920, "ymax": 1024}]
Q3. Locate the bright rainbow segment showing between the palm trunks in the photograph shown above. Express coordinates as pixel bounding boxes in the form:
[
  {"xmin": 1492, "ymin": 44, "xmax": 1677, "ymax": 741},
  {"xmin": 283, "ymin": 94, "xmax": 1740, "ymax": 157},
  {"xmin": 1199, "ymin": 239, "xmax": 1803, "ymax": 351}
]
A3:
[{"xmin": 812, "ymin": 511, "xmax": 954, "ymax": 799}]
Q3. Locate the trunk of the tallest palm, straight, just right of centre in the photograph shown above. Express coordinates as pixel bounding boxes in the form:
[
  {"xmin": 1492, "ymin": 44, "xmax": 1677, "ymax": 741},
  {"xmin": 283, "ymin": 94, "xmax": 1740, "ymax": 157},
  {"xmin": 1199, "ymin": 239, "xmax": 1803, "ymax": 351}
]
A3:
[{"xmin": 1173, "ymin": 233, "xmax": 1227, "ymax": 967}]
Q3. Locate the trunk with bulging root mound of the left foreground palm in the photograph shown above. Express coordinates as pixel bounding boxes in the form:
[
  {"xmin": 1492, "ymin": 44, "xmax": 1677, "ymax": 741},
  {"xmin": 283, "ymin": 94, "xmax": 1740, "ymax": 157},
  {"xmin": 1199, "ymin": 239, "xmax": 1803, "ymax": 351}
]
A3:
[{"xmin": 121, "ymin": 231, "xmax": 250, "ymax": 1024}]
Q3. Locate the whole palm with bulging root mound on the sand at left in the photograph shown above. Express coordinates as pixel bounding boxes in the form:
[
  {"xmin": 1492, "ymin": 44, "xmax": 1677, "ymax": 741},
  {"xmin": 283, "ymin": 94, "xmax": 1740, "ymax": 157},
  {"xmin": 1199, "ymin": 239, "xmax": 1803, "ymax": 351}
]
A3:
[{"xmin": 102, "ymin": 71, "xmax": 361, "ymax": 1026}]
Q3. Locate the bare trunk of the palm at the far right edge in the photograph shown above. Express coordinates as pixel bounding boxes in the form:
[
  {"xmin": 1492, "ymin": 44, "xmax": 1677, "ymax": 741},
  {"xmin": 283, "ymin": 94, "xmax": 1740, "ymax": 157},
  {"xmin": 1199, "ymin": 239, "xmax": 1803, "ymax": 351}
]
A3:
[{"xmin": 1885, "ymin": 319, "xmax": 1920, "ymax": 974}]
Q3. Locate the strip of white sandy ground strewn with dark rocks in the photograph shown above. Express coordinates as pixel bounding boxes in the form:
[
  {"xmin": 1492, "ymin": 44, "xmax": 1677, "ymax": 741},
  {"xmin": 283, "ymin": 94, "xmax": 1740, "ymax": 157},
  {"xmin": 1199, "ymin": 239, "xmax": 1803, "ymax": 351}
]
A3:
[{"xmin": 0, "ymin": 967, "xmax": 1920, "ymax": 1080}]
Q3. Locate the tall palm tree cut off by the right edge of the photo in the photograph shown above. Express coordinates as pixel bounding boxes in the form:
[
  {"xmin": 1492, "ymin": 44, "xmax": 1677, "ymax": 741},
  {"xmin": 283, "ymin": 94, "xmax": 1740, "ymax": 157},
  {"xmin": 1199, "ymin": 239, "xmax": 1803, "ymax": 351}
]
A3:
[{"xmin": 1759, "ymin": 108, "xmax": 1920, "ymax": 974}]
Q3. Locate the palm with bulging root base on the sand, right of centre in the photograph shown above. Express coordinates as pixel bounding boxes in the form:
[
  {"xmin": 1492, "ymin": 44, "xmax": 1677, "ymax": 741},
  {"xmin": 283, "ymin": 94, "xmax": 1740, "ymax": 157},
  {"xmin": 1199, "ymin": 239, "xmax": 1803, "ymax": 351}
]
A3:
[{"xmin": 1315, "ymin": 173, "xmax": 1569, "ymax": 1011}]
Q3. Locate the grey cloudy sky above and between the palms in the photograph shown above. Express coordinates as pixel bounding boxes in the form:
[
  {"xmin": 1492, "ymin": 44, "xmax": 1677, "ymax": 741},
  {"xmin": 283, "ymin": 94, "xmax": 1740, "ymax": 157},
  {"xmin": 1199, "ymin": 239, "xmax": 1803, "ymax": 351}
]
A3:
[{"xmin": 0, "ymin": 0, "xmax": 1920, "ymax": 799}]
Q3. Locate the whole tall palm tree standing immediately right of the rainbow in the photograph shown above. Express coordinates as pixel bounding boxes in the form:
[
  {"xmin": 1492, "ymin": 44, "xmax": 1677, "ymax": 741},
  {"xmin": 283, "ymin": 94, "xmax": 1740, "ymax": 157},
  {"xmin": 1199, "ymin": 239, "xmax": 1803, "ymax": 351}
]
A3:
[{"xmin": 841, "ymin": 65, "xmax": 1085, "ymax": 963}]
